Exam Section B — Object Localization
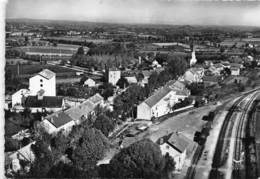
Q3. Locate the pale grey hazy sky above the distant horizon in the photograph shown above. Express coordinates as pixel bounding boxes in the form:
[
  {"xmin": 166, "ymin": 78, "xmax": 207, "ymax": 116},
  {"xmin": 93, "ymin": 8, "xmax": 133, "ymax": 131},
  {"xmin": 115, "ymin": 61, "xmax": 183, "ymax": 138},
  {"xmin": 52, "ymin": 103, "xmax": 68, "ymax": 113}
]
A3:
[{"xmin": 6, "ymin": 0, "xmax": 260, "ymax": 26}]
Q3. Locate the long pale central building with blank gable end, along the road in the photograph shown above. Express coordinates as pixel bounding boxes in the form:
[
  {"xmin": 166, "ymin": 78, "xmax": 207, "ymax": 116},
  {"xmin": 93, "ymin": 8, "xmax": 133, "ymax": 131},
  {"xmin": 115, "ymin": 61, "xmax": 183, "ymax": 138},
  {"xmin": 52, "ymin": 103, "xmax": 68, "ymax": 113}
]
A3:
[{"xmin": 137, "ymin": 86, "xmax": 190, "ymax": 120}]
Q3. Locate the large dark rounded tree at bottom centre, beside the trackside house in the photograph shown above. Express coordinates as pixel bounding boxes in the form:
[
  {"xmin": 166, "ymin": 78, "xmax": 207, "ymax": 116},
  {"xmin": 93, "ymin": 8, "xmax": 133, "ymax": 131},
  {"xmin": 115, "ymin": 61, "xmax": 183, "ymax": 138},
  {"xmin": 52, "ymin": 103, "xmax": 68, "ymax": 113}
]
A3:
[{"xmin": 104, "ymin": 139, "xmax": 175, "ymax": 178}]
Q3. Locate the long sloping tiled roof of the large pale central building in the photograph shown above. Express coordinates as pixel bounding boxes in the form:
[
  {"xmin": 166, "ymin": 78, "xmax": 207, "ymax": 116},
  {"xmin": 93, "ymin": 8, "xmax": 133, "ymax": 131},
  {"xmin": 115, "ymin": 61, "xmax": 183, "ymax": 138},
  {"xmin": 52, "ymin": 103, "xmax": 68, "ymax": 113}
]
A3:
[{"xmin": 144, "ymin": 87, "xmax": 171, "ymax": 107}]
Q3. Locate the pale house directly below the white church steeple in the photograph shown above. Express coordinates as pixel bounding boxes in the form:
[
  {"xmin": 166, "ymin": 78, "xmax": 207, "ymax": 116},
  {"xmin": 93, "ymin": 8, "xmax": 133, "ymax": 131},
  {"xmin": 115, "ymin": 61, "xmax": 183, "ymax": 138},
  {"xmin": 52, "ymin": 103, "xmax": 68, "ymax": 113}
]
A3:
[{"xmin": 183, "ymin": 68, "xmax": 205, "ymax": 83}]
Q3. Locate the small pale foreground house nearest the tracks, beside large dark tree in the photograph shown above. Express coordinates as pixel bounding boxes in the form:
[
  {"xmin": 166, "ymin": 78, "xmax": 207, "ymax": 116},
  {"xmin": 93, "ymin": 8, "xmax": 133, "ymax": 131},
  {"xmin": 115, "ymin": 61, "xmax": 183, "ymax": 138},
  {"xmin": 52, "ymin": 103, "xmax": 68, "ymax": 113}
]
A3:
[{"xmin": 157, "ymin": 132, "xmax": 191, "ymax": 173}]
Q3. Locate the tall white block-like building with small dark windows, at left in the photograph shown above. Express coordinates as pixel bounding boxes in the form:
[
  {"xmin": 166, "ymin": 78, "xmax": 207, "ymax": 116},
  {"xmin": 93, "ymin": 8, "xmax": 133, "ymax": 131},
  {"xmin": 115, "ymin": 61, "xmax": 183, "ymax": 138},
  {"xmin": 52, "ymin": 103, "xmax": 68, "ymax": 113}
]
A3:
[{"xmin": 29, "ymin": 69, "xmax": 56, "ymax": 96}]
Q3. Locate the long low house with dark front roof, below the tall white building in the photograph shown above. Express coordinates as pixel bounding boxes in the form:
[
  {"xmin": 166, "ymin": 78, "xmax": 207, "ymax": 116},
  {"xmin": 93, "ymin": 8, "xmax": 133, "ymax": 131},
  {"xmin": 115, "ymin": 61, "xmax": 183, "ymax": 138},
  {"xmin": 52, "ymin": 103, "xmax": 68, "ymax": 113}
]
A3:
[{"xmin": 41, "ymin": 94, "xmax": 104, "ymax": 134}]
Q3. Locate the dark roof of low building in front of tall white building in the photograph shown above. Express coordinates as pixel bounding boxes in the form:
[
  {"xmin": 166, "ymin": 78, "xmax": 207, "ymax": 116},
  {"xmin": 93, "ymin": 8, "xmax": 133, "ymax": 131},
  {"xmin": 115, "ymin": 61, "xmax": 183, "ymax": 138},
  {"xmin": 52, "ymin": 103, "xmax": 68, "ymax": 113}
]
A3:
[{"xmin": 24, "ymin": 96, "xmax": 63, "ymax": 108}]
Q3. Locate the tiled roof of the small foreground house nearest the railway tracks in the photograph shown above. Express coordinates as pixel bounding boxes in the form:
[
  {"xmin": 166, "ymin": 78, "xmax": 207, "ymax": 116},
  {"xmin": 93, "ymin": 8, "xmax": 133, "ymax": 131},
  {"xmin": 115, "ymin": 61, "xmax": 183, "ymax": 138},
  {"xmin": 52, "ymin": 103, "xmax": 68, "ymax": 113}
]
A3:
[{"xmin": 167, "ymin": 132, "xmax": 190, "ymax": 153}]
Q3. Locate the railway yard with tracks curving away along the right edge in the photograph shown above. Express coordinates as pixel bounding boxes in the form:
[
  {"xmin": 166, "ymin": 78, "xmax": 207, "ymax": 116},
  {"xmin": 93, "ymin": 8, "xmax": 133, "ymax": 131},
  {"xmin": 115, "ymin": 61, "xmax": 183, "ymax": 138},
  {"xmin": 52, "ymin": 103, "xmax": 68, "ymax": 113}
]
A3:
[{"xmin": 186, "ymin": 91, "xmax": 259, "ymax": 179}]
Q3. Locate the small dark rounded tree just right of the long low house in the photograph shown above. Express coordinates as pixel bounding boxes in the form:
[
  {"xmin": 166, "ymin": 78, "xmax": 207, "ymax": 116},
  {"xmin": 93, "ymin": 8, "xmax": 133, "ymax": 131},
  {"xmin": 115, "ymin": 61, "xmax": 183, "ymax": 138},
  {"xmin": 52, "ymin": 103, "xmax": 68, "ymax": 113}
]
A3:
[{"xmin": 94, "ymin": 114, "xmax": 115, "ymax": 136}]
